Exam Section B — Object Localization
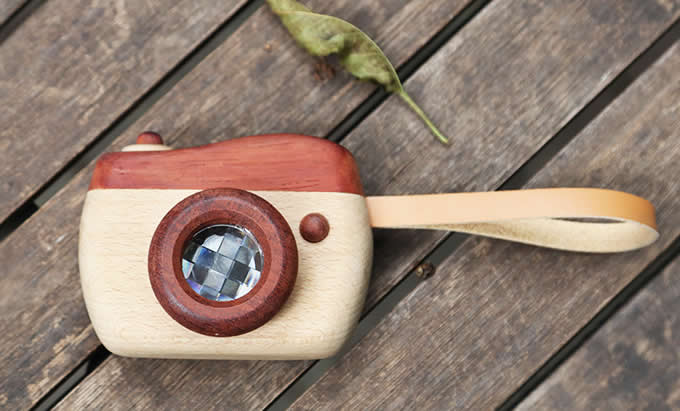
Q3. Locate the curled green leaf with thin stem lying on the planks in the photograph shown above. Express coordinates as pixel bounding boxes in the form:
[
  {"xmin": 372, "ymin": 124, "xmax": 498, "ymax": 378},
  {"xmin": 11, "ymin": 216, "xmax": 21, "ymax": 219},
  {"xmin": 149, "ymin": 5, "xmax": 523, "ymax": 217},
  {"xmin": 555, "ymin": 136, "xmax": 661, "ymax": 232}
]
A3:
[{"xmin": 267, "ymin": 0, "xmax": 449, "ymax": 143}]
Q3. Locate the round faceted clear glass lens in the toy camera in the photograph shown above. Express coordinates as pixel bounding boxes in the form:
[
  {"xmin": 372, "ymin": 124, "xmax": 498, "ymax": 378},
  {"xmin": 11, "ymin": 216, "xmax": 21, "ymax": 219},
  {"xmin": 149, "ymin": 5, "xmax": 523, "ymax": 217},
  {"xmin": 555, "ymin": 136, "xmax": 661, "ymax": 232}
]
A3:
[{"xmin": 182, "ymin": 224, "xmax": 263, "ymax": 301}]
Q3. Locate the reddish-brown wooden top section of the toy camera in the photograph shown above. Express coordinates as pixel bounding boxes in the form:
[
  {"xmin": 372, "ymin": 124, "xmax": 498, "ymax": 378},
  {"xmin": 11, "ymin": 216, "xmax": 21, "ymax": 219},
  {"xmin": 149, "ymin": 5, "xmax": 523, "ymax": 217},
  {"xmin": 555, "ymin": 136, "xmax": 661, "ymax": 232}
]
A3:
[{"xmin": 90, "ymin": 134, "xmax": 363, "ymax": 194}]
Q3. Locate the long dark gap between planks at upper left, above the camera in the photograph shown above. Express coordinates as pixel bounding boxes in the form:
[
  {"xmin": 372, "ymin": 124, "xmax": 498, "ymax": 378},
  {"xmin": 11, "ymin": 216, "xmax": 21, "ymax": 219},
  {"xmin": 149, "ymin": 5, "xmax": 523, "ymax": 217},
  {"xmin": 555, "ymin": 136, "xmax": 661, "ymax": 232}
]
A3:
[{"xmin": 0, "ymin": 0, "xmax": 264, "ymax": 242}]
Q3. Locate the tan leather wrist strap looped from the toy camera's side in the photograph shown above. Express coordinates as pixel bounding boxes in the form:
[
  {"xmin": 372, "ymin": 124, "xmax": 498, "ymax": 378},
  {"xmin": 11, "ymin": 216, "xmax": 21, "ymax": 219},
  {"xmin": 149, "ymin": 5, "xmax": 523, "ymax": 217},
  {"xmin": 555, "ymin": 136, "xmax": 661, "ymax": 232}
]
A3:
[{"xmin": 366, "ymin": 188, "xmax": 659, "ymax": 253}]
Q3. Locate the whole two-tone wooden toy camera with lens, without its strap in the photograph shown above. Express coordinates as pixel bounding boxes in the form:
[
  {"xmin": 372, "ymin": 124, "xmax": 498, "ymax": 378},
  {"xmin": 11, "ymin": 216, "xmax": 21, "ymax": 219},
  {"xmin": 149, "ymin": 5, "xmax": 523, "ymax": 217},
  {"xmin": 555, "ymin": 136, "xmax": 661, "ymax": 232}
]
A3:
[{"xmin": 79, "ymin": 133, "xmax": 373, "ymax": 359}]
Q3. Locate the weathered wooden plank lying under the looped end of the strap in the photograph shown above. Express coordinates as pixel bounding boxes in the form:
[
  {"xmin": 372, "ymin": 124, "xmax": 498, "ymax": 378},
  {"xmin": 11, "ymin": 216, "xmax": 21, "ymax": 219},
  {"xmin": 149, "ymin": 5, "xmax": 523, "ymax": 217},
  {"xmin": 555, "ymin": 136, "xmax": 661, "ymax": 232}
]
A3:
[{"xmin": 295, "ymin": 37, "xmax": 680, "ymax": 409}]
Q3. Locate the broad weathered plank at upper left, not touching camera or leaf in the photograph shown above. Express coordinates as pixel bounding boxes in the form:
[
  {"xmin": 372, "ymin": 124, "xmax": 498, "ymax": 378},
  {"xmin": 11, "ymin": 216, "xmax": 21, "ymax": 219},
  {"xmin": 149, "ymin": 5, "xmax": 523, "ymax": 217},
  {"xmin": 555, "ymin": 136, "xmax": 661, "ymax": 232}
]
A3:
[{"xmin": 0, "ymin": 0, "xmax": 245, "ymax": 225}]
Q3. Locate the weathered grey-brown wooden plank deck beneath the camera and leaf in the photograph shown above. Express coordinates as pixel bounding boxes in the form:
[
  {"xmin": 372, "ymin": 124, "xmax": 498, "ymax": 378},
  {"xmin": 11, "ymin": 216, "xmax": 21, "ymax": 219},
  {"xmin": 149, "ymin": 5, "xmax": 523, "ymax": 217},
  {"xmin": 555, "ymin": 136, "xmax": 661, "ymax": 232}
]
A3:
[{"xmin": 0, "ymin": 0, "xmax": 680, "ymax": 409}]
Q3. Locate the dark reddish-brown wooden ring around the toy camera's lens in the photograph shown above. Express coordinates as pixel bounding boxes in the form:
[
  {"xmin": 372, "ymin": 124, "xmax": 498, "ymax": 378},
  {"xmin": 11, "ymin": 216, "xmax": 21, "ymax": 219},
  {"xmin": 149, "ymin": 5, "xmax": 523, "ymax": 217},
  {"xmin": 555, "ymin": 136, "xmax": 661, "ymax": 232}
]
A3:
[{"xmin": 149, "ymin": 188, "xmax": 298, "ymax": 337}]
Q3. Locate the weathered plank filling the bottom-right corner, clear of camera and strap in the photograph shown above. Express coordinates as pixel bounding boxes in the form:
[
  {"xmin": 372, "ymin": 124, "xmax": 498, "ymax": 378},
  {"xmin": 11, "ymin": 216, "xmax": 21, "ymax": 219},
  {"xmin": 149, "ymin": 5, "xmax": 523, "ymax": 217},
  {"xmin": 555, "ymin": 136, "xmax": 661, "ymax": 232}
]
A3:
[{"xmin": 518, "ymin": 258, "xmax": 680, "ymax": 410}]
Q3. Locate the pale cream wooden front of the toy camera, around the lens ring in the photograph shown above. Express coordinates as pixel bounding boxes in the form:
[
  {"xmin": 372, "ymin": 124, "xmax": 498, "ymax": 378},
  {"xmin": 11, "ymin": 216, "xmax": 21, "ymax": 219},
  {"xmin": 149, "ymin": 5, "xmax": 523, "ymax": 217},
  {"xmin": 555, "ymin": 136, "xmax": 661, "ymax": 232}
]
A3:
[{"xmin": 79, "ymin": 189, "xmax": 373, "ymax": 360}]
